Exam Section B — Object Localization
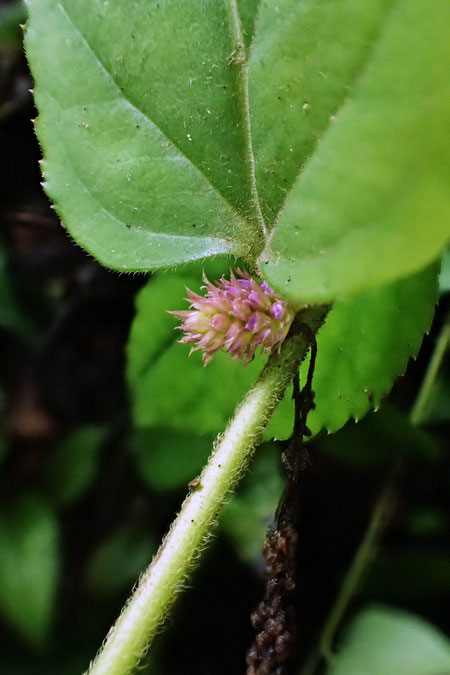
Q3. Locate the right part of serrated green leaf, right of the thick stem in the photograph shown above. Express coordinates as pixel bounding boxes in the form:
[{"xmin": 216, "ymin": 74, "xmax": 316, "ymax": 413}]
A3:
[{"xmin": 266, "ymin": 265, "xmax": 438, "ymax": 440}]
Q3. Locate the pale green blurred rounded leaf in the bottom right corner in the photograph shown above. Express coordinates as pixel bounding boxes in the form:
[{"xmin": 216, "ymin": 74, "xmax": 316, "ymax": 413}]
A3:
[{"xmin": 326, "ymin": 607, "xmax": 450, "ymax": 675}]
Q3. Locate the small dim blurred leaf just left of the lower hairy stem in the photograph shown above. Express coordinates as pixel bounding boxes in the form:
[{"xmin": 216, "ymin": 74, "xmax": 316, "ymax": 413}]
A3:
[{"xmin": 86, "ymin": 525, "xmax": 155, "ymax": 596}]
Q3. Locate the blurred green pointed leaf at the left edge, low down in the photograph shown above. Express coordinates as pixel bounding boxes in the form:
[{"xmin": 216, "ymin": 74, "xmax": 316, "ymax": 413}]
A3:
[{"xmin": 0, "ymin": 495, "xmax": 59, "ymax": 646}]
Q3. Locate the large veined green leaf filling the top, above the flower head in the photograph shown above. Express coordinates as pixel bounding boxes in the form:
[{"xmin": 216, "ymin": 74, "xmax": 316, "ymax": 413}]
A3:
[{"xmin": 26, "ymin": 0, "xmax": 450, "ymax": 303}]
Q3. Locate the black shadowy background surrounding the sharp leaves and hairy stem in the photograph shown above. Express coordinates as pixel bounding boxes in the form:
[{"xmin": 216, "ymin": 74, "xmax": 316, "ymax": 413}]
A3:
[{"xmin": 0, "ymin": 2, "xmax": 450, "ymax": 675}]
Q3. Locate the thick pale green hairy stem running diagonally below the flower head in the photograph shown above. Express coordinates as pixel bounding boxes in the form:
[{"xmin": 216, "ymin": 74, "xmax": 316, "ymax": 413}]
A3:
[{"xmin": 88, "ymin": 309, "xmax": 324, "ymax": 675}]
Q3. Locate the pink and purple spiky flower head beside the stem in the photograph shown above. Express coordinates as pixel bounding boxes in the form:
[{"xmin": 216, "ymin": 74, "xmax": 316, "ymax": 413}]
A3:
[{"xmin": 169, "ymin": 270, "xmax": 294, "ymax": 366}]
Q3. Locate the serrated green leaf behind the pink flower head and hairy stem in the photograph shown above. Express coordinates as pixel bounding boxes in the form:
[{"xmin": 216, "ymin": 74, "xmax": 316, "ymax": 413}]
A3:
[{"xmin": 128, "ymin": 266, "xmax": 438, "ymax": 440}]
